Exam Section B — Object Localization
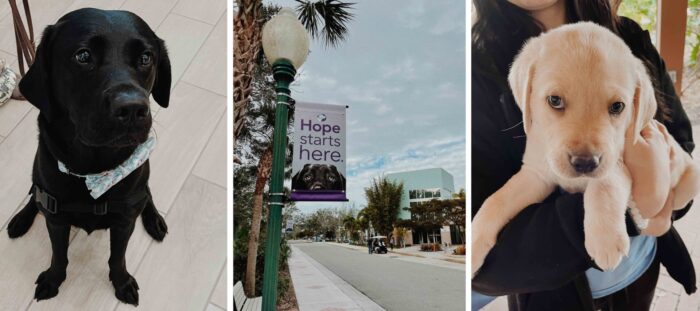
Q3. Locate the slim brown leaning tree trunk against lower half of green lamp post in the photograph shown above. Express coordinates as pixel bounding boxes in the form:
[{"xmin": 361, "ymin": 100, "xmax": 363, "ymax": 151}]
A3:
[{"xmin": 243, "ymin": 143, "xmax": 272, "ymax": 297}]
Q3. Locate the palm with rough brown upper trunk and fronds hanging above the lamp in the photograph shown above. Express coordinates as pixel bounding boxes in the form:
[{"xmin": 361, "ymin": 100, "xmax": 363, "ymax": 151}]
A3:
[{"xmin": 233, "ymin": 0, "xmax": 354, "ymax": 161}]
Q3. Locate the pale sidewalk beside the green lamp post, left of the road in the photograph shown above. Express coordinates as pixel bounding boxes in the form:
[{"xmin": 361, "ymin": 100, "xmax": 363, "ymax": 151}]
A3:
[{"xmin": 287, "ymin": 244, "xmax": 384, "ymax": 311}]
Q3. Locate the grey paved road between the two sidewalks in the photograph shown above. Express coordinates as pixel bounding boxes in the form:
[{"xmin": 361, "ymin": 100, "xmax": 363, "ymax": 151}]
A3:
[{"xmin": 295, "ymin": 243, "xmax": 466, "ymax": 311}]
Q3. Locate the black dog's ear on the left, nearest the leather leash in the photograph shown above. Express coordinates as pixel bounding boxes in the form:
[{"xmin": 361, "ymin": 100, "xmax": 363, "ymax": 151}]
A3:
[{"xmin": 19, "ymin": 26, "xmax": 54, "ymax": 120}]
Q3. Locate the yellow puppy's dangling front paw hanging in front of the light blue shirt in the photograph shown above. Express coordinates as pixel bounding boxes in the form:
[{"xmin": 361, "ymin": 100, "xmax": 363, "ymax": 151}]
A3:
[{"xmin": 585, "ymin": 233, "xmax": 630, "ymax": 271}]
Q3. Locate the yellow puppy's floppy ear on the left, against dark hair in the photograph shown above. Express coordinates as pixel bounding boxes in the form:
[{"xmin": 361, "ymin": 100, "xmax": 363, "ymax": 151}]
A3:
[{"xmin": 508, "ymin": 38, "xmax": 538, "ymax": 133}]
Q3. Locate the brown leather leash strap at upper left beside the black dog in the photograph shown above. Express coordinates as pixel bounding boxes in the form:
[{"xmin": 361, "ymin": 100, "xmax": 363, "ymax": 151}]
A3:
[{"xmin": 8, "ymin": 0, "xmax": 36, "ymax": 77}]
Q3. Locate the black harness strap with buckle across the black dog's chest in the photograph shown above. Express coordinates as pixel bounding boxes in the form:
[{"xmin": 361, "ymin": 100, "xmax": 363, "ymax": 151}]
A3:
[{"xmin": 29, "ymin": 184, "xmax": 151, "ymax": 216}]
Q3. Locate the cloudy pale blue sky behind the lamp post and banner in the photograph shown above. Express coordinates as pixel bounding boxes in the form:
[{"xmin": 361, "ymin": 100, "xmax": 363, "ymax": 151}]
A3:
[{"xmin": 264, "ymin": 0, "xmax": 466, "ymax": 213}]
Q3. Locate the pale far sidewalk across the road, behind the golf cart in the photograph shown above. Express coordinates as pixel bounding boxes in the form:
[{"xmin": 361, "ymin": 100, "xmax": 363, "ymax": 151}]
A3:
[{"xmin": 324, "ymin": 242, "xmax": 466, "ymax": 271}]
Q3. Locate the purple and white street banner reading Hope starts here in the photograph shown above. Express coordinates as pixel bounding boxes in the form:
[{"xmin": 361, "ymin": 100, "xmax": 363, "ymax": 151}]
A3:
[{"xmin": 291, "ymin": 102, "xmax": 348, "ymax": 201}]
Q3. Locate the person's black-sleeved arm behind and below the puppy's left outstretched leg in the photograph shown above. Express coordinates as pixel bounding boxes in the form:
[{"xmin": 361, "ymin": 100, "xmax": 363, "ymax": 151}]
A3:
[{"xmin": 472, "ymin": 77, "xmax": 593, "ymax": 296}]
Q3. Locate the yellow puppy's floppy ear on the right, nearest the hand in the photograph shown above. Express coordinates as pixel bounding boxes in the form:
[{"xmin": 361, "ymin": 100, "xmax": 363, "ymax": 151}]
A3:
[{"xmin": 630, "ymin": 60, "xmax": 657, "ymax": 143}]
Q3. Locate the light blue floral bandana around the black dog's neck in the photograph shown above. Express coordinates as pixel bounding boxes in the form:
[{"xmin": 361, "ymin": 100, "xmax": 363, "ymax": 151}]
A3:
[{"xmin": 58, "ymin": 132, "xmax": 156, "ymax": 199}]
